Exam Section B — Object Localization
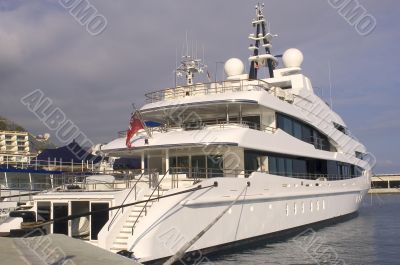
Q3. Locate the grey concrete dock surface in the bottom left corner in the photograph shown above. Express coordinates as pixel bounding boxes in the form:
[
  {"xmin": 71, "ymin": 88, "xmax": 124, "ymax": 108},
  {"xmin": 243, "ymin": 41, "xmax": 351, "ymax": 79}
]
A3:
[{"xmin": 0, "ymin": 234, "xmax": 140, "ymax": 265}]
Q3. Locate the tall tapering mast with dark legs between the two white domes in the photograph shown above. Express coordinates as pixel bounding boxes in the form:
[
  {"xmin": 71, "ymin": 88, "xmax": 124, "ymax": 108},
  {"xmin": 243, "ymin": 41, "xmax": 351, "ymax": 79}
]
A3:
[{"xmin": 249, "ymin": 3, "xmax": 278, "ymax": 79}]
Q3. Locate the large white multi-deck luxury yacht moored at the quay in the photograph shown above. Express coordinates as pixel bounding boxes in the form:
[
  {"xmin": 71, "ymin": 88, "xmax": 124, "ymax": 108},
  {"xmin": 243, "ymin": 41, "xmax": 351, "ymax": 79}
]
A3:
[{"xmin": 16, "ymin": 5, "xmax": 371, "ymax": 262}]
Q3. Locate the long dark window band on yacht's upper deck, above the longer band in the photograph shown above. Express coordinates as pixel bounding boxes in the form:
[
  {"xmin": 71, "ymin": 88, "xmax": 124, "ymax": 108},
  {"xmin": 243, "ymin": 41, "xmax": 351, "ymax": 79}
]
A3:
[{"xmin": 276, "ymin": 113, "xmax": 336, "ymax": 152}]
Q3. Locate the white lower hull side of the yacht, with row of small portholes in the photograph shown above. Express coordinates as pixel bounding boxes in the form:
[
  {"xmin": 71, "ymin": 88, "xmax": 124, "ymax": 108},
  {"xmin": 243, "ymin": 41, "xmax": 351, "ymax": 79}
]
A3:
[{"xmin": 128, "ymin": 173, "xmax": 368, "ymax": 262}]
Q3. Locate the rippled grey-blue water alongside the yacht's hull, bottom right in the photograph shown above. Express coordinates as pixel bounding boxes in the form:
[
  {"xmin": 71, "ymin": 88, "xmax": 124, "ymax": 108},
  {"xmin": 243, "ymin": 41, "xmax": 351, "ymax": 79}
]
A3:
[{"xmin": 211, "ymin": 194, "xmax": 400, "ymax": 265}]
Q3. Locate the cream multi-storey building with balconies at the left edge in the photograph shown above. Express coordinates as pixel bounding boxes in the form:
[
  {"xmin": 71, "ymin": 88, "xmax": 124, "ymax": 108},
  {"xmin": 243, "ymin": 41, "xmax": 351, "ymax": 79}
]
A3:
[{"xmin": 0, "ymin": 131, "xmax": 30, "ymax": 164}]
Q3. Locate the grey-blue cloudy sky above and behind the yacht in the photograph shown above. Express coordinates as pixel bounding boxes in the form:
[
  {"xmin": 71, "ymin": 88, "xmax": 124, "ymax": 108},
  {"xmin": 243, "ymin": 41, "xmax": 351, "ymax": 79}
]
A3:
[{"xmin": 0, "ymin": 0, "xmax": 400, "ymax": 173}]
